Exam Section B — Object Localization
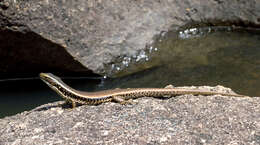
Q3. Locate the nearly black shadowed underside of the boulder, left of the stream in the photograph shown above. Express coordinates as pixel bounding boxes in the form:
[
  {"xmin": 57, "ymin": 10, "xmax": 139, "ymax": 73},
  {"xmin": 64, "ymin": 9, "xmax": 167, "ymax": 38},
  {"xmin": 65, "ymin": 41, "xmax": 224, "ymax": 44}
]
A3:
[{"xmin": 0, "ymin": 30, "xmax": 89, "ymax": 79}]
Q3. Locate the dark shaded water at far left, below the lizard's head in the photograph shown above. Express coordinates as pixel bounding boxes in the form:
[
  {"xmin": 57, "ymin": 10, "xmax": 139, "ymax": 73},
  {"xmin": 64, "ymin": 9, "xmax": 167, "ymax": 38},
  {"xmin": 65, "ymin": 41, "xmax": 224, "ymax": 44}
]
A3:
[{"xmin": 0, "ymin": 80, "xmax": 58, "ymax": 117}]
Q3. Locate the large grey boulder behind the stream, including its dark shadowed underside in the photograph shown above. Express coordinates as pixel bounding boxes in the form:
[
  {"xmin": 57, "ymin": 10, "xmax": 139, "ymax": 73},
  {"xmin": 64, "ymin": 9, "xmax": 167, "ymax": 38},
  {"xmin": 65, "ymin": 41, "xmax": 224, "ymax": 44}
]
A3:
[{"xmin": 0, "ymin": 0, "xmax": 260, "ymax": 74}]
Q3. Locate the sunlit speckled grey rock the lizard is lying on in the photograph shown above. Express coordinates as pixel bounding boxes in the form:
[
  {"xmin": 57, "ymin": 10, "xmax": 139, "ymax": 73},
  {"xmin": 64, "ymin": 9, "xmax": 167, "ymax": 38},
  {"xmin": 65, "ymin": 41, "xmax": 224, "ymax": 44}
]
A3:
[{"xmin": 0, "ymin": 86, "xmax": 260, "ymax": 145}]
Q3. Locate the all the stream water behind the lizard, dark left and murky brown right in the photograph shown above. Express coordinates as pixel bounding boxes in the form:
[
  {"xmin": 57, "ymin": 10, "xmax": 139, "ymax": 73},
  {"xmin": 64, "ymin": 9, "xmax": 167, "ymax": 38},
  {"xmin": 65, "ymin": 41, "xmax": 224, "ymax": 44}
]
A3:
[{"xmin": 0, "ymin": 27, "xmax": 260, "ymax": 118}]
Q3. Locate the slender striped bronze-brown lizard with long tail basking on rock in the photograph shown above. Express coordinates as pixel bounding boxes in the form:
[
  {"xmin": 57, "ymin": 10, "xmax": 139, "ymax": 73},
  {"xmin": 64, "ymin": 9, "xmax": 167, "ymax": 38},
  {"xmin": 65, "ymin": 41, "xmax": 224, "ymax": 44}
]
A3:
[{"xmin": 40, "ymin": 73, "xmax": 248, "ymax": 107}]
